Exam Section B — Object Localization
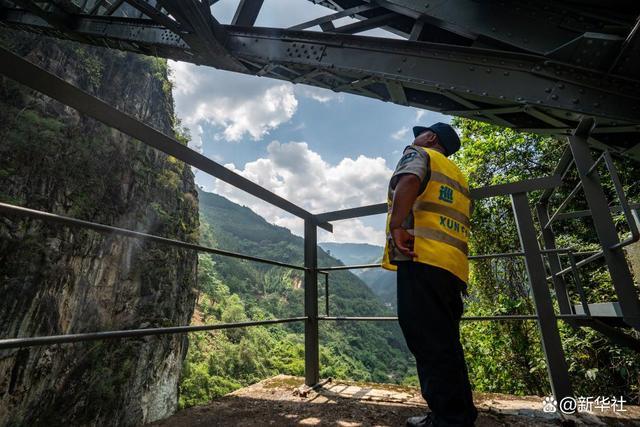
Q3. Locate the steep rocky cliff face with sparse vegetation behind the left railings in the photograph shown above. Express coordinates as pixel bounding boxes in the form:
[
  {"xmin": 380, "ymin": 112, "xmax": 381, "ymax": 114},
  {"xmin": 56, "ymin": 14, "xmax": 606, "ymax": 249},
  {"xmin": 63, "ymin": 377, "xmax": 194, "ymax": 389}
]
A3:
[{"xmin": 0, "ymin": 33, "xmax": 198, "ymax": 425}]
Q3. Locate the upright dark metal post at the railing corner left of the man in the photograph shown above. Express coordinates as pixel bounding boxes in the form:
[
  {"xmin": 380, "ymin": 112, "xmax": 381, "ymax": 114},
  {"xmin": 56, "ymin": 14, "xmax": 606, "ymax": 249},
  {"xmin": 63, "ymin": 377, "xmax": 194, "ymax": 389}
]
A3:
[{"xmin": 304, "ymin": 219, "xmax": 320, "ymax": 386}]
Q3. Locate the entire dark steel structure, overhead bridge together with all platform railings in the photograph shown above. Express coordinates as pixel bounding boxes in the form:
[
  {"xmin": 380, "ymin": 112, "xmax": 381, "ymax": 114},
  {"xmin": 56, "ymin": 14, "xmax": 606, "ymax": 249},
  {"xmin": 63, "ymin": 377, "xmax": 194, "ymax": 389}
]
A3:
[{"xmin": 0, "ymin": 0, "xmax": 640, "ymax": 412}]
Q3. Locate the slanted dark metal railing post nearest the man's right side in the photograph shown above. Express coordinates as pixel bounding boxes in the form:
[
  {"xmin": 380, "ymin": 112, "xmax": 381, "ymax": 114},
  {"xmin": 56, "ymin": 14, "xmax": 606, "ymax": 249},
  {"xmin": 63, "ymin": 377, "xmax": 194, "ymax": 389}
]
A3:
[{"xmin": 511, "ymin": 193, "xmax": 572, "ymax": 402}]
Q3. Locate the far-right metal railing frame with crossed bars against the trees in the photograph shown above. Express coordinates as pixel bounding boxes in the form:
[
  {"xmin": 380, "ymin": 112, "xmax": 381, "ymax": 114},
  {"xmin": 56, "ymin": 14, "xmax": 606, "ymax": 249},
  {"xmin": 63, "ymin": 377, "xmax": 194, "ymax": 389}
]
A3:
[{"xmin": 536, "ymin": 118, "xmax": 640, "ymax": 338}]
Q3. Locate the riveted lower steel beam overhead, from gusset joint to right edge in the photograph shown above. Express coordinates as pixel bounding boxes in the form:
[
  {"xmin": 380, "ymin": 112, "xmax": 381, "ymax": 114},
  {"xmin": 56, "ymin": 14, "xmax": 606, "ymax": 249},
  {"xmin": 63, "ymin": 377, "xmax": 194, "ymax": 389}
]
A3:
[{"xmin": 229, "ymin": 28, "xmax": 640, "ymax": 122}]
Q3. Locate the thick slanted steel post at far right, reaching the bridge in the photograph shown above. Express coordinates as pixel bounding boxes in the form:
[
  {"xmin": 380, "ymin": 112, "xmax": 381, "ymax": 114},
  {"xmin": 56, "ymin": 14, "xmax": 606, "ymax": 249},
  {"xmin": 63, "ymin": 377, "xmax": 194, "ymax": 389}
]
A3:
[{"xmin": 569, "ymin": 119, "xmax": 640, "ymax": 329}]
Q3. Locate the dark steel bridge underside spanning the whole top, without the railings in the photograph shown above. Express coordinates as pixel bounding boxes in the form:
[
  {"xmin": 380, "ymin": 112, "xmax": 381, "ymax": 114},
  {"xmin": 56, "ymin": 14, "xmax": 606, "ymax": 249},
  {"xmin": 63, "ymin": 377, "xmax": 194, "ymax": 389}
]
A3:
[{"xmin": 0, "ymin": 0, "xmax": 640, "ymax": 160}]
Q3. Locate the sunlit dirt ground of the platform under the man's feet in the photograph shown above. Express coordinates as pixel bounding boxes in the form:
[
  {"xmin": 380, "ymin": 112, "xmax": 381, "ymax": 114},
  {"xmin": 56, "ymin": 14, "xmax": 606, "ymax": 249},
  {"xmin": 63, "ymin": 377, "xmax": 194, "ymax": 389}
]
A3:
[{"xmin": 152, "ymin": 375, "xmax": 640, "ymax": 427}]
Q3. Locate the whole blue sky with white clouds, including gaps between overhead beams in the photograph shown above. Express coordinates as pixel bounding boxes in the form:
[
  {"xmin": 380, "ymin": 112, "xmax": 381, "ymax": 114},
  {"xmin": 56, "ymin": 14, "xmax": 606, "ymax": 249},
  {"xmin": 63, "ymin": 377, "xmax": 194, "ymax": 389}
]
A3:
[{"xmin": 170, "ymin": 0, "xmax": 449, "ymax": 244}]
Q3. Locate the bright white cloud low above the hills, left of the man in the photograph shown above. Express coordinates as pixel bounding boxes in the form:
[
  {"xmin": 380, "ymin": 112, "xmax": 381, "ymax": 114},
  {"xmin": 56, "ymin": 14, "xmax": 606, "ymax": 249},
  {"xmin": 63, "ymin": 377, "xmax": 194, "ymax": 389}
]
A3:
[{"xmin": 212, "ymin": 141, "xmax": 392, "ymax": 244}]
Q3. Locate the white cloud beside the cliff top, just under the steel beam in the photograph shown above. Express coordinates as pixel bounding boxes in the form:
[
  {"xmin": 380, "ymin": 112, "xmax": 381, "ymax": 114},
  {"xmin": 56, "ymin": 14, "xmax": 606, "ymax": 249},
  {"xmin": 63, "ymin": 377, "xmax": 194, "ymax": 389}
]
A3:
[{"xmin": 169, "ymin": 61, "xmax": 298, "ymax": 147}]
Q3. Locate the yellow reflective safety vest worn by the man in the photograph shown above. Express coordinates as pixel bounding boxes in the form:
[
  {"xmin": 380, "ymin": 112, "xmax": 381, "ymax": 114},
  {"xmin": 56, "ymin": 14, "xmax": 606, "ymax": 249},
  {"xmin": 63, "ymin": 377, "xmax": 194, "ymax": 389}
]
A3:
[{"xmin": 382, "ymin": 147, "xmax": 471, "ymax": 283}]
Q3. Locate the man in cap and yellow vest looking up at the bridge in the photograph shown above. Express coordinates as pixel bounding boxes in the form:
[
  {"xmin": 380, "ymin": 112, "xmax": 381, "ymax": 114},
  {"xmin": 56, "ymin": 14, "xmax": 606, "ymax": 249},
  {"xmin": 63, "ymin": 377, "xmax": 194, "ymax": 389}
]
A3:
[{"xmin": 382, "ymin": 123, "xmax": 477, "ymax": 427}]
